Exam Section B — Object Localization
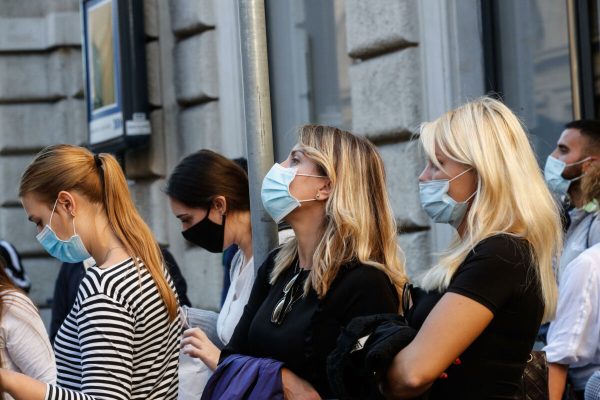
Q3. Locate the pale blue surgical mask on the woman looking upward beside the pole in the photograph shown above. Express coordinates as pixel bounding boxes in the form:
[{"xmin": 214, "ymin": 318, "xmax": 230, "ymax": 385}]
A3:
[{"xmin": 260, "ymin": 163, "xmax": 327, "ymax": 223}]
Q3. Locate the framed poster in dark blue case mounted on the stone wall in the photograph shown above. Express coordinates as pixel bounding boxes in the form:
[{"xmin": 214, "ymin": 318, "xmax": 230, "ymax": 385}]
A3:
[{"xmin": 81, "ymin": 0, "xmax": 151, "ymax": 152}]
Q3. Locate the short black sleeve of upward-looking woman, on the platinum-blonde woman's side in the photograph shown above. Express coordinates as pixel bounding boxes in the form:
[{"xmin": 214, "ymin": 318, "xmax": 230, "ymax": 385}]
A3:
[{"xmin": 333, "ymin": 265, "xmax": 400, "ymax": 325}]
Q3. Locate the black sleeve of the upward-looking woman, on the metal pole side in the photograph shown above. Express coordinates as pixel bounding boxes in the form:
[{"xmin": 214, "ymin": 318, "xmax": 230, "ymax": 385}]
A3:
[{"xmin": 219, "ymin": 253, "xmax": 275, "ymax": 363}]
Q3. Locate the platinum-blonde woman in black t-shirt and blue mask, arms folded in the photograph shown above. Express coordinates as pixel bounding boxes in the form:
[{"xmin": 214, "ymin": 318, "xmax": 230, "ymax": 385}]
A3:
[{"xmin": 384, "ymin": 97, "xmax": 561, "ymax": 400}]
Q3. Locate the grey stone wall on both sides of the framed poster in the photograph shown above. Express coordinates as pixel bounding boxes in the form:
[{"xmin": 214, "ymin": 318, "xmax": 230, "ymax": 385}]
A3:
[{"xmin": 0, "ymin": 0, "xmax": 234, "ymax": 332}]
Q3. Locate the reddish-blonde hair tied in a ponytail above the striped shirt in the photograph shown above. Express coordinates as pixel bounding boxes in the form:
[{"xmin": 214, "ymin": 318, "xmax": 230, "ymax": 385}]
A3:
[{"xmin": 19, "ymin": 144, "xmax": 178, "ymax": 320}]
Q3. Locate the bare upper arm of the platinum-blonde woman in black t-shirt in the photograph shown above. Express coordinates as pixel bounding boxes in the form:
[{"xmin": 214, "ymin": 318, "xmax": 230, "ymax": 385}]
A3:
[{"xmin": 387, "ymin": 293, "xmax": 493, "ymax": 398}]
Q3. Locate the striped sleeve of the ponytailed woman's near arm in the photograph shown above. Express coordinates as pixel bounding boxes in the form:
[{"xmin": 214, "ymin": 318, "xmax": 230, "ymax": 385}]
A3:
[{"xmin": 45, "ymin": 294, "xmax": 134, "ymax": 400}]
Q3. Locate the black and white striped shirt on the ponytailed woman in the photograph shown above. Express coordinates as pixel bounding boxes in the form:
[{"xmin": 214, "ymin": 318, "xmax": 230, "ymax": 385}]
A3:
[{"xmin": 46, "ymin": 259, "xmax": 182, "ymax": 400}]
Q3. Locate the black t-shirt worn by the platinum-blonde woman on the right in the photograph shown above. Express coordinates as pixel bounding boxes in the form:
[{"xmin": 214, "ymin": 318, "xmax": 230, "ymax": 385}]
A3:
[{"xmin": 408, "ymin": 235, "xmax": 544, "ymax": 400}]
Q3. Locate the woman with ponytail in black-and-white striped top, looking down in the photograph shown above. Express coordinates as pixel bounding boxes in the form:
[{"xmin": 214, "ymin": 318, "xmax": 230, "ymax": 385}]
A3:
[{"xmin": 0, "ymin": 145, "xmax": 182, "ymax": 400}]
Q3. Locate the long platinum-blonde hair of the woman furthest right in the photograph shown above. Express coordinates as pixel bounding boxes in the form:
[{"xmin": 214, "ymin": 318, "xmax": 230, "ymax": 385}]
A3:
[{"xmin": 420, "ymin": 97, "xmax": 562, "ymax": 320}]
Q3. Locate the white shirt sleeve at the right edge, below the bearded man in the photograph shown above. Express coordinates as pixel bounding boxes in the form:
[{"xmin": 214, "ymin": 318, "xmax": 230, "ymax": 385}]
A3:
[{"xmin": 544, "ymin": 253, "xmax": 600, "ymax": 367}]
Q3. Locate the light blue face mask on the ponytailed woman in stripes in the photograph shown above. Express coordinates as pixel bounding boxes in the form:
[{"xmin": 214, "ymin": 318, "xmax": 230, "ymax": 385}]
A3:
[{"xmin": 36, "ymin": 199, "xmax": 91, "ymax": 263}]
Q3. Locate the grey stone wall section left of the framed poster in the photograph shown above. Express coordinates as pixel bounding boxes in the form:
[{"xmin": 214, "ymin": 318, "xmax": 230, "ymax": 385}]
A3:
[{"xmin": 0, "ymin": 0, "xmax": 86, "ymax": 321}]
